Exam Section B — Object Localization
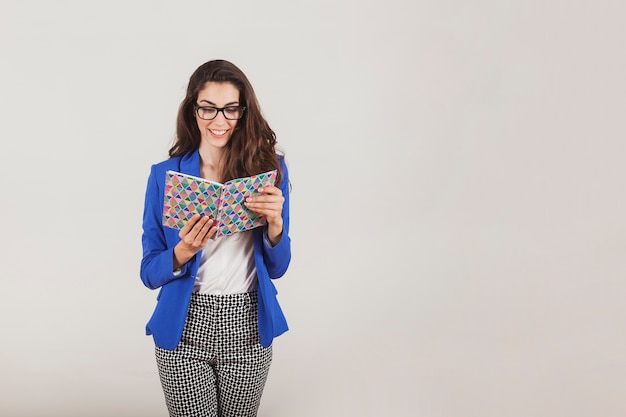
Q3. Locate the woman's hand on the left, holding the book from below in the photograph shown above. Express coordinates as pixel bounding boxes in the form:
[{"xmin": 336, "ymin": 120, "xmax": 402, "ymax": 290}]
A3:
[{"xmin": 174, "ymin": 214, "xmax": 217, "ymax": 269}]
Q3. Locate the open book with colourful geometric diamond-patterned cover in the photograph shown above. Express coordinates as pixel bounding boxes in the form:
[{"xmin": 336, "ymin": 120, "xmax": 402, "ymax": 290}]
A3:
[{"xmin": 163, "ymin": 170, "xmax": 276, "ymax": 239}]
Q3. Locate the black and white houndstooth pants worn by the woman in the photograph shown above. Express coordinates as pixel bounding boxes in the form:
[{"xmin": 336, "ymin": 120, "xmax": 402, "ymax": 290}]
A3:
[{"xmin": 155, "ymin": 291, "xmax": 272, "ymax": 417}]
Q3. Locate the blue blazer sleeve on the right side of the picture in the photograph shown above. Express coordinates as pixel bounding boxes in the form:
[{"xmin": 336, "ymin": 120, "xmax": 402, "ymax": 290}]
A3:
[{"xmin": 263, "ymin": 156, "xmax": 291, "ymax": 279}]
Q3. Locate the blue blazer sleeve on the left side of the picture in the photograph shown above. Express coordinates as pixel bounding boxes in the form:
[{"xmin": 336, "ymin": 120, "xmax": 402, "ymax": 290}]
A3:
[{"xmin": 140, "ymin": 165, "xmax": 189, "ymax": 289}]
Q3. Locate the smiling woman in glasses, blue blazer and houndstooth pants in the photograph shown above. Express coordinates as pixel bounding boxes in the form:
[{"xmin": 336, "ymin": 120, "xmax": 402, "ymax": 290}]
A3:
[{"xmin": 141, "ymin": 60, "xmax": 291, "ymax": 417}]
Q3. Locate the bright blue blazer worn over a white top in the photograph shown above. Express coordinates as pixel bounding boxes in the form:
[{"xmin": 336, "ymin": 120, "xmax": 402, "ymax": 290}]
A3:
[{"xmin": 140, "ymin": 150, "xmax": 291, "ymax": 350}]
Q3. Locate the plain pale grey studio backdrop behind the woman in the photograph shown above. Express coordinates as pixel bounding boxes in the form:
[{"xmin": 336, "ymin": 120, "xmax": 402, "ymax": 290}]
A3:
[{"xmin": 0, "ymin": 0, "xmax": 626, "ymax": 417}]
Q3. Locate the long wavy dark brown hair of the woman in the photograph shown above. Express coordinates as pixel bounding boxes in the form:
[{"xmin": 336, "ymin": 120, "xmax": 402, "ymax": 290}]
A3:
[{"xmin": 169, "ymin": 59, "xmax": 282, "ymax": 185}]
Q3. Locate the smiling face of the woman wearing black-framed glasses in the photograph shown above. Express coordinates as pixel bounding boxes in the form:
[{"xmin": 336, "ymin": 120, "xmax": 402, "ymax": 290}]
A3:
[{"xmin": 195, "ymin": 81, "xmax": 241, "ymax": 148}]
